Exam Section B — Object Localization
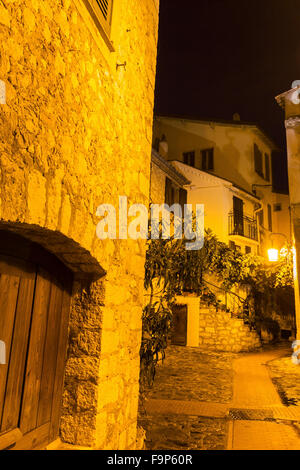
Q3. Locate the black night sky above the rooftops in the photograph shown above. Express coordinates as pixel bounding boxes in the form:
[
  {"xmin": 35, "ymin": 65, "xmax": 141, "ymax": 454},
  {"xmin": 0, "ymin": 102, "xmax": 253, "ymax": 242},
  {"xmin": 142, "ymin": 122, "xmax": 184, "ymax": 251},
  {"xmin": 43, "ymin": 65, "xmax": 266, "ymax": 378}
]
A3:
[{"xmin": 155, "ymin": 0, "xmax": 300, "ymax": 195}]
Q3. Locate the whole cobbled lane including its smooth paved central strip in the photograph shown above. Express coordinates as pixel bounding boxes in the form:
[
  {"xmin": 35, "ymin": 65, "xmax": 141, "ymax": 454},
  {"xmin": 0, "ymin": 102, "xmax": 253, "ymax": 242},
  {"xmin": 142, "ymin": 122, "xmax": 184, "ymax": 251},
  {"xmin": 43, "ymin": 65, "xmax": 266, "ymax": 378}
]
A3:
[{"xmin": 140, "ymin": 345, "xmax": 300, "ymax": 450}]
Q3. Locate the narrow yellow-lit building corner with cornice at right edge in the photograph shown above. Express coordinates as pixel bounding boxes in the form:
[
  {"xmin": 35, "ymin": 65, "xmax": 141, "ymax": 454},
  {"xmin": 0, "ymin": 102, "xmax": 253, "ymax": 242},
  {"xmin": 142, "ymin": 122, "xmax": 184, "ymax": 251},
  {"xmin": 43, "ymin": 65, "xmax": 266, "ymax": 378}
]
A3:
[{"xmin": 276, "ymin": 80, "xmax": 300, "ymax": 340}]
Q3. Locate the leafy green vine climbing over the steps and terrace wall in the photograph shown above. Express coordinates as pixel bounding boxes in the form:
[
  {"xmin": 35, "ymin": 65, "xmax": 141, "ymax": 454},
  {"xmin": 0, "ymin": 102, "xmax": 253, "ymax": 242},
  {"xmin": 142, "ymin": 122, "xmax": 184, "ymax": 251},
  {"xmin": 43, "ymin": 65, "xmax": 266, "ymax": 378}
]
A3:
[{"xmin": 140, "ymin": 230, "xmax": 293, "ymax": 393}]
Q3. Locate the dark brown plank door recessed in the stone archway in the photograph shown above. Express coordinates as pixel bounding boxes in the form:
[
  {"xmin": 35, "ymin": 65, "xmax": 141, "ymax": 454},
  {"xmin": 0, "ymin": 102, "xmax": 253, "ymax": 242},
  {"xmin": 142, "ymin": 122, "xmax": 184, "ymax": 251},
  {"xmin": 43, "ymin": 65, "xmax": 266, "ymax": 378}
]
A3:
[{"xmin": 0, "ymin": 231, "xmax": 72, "ymax": 449}]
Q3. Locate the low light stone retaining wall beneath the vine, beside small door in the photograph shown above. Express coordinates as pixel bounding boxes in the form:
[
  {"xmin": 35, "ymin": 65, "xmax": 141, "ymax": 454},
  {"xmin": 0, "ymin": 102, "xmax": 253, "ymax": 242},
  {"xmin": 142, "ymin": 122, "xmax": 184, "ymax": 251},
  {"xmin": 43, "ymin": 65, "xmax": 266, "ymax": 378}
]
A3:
[{"xmin": 199, "ymin": 307, "xmax": 261, "ymax": 352}]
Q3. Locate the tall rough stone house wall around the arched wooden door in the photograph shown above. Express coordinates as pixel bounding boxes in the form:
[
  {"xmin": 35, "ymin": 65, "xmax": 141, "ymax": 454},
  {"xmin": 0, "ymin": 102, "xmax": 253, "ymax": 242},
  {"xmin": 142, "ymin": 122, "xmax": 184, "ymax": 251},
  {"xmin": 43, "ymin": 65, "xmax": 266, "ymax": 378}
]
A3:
[{"xmin": 0, "ymin": 0, "xmax": 158, "ymax": 449}]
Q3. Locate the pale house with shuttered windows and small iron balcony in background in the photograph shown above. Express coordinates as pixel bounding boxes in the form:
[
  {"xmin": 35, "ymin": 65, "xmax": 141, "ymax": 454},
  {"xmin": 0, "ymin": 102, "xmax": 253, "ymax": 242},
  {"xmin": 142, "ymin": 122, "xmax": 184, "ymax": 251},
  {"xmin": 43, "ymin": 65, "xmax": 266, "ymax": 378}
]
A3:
[{"xmin": 153, "ymin": 117, "xmax": 290, "ymax": 256}]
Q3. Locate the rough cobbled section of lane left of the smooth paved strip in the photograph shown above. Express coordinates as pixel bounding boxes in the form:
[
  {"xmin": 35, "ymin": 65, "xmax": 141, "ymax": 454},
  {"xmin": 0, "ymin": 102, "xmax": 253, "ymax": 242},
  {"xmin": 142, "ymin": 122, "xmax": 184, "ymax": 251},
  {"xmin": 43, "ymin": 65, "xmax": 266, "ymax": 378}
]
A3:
[{"xmin": 140, "ymin": 346, "xmax": 236, "ymax": 450}]
